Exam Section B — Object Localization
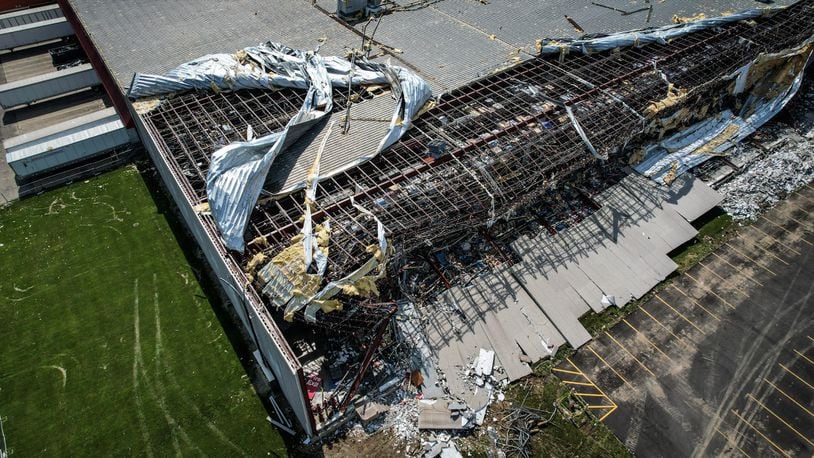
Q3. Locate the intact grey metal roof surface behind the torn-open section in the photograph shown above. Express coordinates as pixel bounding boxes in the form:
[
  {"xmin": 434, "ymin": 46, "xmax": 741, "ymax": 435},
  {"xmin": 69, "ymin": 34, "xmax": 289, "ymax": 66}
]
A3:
[{"xmin": 69, "ymin": 0, "xmax": 793, "ymax": 92}]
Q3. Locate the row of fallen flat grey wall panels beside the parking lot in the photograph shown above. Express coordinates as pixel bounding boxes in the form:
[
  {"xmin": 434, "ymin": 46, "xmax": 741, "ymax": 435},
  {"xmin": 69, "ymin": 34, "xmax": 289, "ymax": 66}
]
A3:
[{"xmin": 414, "ymin": 176, "xmax": 716, "ymax": 408}]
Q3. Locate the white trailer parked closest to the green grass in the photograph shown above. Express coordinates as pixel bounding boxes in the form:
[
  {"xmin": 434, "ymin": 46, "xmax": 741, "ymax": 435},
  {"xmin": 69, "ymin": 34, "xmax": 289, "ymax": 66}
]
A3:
[{"xmin": 3, "ymin": 108, "xmax": 131, "ymax": 176}]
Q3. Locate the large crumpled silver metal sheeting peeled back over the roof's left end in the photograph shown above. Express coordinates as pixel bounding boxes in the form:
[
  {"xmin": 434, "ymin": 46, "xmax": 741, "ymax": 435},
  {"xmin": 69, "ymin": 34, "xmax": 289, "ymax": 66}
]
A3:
[{"xmin": 128, "ymin": 42, "xmax": 432, "ymax": 251}]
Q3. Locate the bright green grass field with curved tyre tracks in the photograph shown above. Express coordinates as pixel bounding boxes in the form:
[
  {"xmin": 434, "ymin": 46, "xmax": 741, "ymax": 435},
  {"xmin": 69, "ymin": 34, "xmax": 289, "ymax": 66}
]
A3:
[{"xmin": 0, "ymin": 166, "xmax": 285, "ymax": 456}]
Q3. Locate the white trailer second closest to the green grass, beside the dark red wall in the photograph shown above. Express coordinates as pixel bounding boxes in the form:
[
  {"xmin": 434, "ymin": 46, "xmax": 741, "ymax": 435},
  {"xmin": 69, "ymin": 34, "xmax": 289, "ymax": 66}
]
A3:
[{"xmin": 0, "ymin": 64, "xmax": 99, "ymax": 109}]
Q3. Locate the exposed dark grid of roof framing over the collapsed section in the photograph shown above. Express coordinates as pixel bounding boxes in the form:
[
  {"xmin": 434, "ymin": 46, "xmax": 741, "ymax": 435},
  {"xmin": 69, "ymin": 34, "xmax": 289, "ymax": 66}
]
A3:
[{"xmin": 139, "ymin": 0, "xmax": 814, "ymax": 328}]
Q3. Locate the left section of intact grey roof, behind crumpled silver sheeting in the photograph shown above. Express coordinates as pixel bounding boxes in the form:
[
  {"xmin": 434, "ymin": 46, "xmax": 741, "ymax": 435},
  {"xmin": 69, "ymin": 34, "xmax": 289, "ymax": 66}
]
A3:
[{"xmin": 70, "ymin": 0, "xmax": 361, "ymax": 87}]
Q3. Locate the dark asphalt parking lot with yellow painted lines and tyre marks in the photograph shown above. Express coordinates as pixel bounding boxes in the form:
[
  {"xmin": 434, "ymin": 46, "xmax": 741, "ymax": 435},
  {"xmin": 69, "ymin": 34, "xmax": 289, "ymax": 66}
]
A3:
[{"xmin": 555, "ymin": 187, "xmax": 814, "ymax": 456}]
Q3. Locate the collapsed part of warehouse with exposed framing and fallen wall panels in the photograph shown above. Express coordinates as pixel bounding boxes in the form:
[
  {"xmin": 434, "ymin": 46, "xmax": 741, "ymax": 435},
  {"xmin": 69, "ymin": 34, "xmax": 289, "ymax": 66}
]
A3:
[{"xmin": 60, "ymin": 0, "xmax": 814, "ymax": 436}]
